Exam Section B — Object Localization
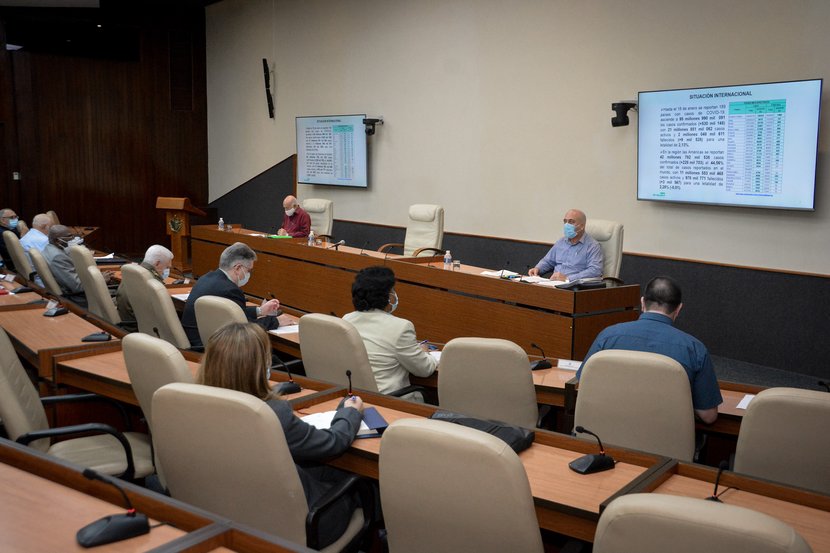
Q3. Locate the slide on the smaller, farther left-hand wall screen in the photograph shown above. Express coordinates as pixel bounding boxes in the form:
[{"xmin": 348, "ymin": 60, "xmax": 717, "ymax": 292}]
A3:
[{"xmin": 297, "ymin": 115, "xmax": 368, "ymax": 188}]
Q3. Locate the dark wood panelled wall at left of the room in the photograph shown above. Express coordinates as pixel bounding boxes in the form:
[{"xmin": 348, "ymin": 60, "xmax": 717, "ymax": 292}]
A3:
[{"xmin": 2, "ymin": 7, "xmax": 207, "ymax": 253}]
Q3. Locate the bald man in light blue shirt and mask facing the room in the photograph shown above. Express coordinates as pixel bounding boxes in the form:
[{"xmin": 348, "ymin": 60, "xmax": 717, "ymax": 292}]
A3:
[{"xmin": 527, "ymin": 209, "xmax": 603, "ymax": 280}]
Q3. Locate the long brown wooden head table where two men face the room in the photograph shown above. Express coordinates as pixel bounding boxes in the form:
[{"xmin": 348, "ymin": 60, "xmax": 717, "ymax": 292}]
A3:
[{"xmin": 191, "ymin": 225, "xmax": 640, "ymax": 359}]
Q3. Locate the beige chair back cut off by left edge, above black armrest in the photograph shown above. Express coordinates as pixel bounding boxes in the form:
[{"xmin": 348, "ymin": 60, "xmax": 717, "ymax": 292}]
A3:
[{"xmin": 0, "ymin": 328, "xmax": 49, "ymax": 452}]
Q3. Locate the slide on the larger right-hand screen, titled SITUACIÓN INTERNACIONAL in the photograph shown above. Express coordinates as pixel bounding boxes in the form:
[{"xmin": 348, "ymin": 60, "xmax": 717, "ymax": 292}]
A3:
[{"xmin": 637, "ymin": 79, "xmax": 822, "ymax": 210}]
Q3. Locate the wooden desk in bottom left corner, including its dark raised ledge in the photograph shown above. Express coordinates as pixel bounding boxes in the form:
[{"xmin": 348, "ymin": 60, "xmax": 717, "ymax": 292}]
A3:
[{"xmin": 0, "ymin": 438, "xmax": 311, "ymax": 553}]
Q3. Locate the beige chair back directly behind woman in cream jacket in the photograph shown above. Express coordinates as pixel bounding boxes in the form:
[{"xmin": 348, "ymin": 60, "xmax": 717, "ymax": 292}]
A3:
[{"xmin": 300, "ymin": 313, "xmax": 378, "ymax": 392}]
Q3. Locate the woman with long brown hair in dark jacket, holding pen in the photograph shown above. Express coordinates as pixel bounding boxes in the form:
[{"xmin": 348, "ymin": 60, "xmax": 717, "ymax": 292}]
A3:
[{"xmin": 196, "ymin": 323, "xmax": 363, "ymax": 547}]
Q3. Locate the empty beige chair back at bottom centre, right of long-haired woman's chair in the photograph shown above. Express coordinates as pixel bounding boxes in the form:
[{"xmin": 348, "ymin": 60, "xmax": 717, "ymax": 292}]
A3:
[{"xmin": 379, "ymin": 419, "xmax": 543, "ymax": 553}]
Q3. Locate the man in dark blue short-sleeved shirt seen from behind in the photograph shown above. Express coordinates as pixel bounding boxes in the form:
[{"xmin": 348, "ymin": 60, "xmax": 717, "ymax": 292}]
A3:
[{"xmin": 576, "ymin": 277, "xmax": 723, "ymax": 424}]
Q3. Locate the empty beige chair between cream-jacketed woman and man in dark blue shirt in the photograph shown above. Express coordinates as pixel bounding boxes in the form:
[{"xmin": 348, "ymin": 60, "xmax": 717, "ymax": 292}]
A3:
[{"xmin": 438, "ymin": 338, "xmax": 539, "ymax": 428}]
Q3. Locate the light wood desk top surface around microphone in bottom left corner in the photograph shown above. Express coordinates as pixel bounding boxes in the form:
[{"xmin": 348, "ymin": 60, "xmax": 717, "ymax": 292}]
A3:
[{"xmin": 0, "ymin": 464, "xmax": 185, "ymax": 553}]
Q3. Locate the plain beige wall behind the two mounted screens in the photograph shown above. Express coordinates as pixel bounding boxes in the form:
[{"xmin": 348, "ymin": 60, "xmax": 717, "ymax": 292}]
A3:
[{"xmin": 206, "ymin": 0, "xmax": 830, "ymax": 274}]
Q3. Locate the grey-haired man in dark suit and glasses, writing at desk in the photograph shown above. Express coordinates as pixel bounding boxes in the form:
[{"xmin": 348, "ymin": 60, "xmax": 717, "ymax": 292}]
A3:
[{"xmin": 182, "ymin": 242, "xmax": 280, "ymax": 347}]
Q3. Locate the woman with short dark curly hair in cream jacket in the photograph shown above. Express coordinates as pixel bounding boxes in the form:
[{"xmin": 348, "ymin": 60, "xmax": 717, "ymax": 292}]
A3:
[{"xmin": 343, "ymin": 267, "xmax": 437, "ymax": 401}]
